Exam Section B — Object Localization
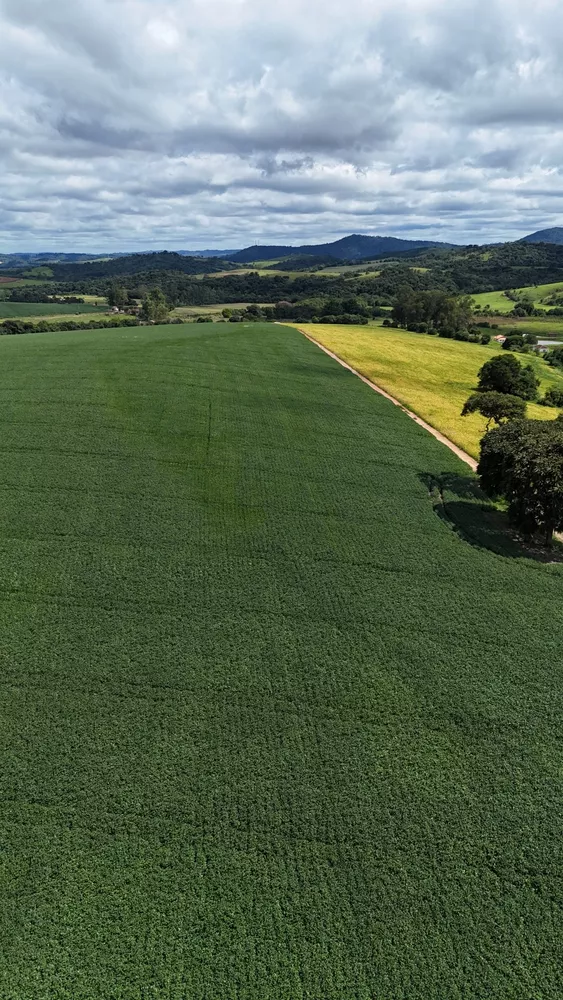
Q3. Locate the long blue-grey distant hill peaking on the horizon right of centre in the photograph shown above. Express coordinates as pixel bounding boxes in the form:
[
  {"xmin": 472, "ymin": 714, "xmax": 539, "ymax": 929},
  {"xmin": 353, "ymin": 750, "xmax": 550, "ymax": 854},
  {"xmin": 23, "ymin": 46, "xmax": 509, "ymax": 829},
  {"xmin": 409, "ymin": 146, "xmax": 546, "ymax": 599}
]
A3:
[{"xmin": 229, "ymin": 234, "xmax": 454, "ymax": 264}]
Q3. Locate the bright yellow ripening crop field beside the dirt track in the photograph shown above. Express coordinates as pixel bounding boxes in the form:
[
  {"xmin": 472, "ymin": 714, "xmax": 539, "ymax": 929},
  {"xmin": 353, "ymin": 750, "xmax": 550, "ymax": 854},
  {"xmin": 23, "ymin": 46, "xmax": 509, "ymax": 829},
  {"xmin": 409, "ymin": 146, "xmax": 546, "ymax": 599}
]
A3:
[{"xmin": 296, "ymin": 320, "xmax": 563, "ymax": 458}]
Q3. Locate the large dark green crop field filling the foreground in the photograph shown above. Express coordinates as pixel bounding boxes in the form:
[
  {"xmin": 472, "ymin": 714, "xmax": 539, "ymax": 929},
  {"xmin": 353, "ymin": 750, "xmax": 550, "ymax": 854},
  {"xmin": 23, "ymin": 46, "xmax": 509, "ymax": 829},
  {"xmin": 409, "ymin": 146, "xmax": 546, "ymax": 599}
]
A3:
[{"xmin": 0, "ymin": 324, "xmax": 563, "ymax": 1000}]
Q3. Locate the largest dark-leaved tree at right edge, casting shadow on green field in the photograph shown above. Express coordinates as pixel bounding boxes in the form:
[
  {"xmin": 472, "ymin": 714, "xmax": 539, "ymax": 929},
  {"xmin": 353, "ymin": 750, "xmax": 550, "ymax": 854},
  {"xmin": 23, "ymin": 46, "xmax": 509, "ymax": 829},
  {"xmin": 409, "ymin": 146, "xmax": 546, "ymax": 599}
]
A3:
[{"xmin": 478, "ymin": 420, "xmax": 563, "ymax": 545}]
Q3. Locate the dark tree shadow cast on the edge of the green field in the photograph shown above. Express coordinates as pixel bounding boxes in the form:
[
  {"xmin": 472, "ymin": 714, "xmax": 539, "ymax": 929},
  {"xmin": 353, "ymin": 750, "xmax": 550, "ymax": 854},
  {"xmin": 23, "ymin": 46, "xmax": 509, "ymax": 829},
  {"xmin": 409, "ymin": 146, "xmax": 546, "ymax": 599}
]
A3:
[{"xmin": 419, "ymin": 472, "xmax": 563, "ymax": 563}]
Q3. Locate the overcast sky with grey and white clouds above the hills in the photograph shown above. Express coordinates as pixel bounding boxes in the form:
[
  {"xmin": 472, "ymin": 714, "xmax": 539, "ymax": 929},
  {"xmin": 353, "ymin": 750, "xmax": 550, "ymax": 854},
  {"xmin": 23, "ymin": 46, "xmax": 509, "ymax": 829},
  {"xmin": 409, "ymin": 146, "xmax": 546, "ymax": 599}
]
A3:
[{"xmin": 0, "ymin": 0, "xmax": 563, "ymax": 253}]
